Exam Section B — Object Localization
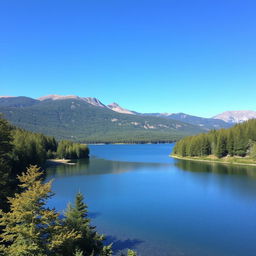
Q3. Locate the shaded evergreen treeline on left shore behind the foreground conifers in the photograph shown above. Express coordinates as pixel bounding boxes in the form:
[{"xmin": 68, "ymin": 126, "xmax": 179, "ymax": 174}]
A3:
[{"xmin": 0, "ymin": 117, "xmax": 89, "ymax": 208}]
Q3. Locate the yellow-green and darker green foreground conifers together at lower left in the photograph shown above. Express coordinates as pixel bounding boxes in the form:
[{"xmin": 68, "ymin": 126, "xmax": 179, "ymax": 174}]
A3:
[{"xmin": 0, "ymin": 166, "xmax": 136, "ymax": 256}]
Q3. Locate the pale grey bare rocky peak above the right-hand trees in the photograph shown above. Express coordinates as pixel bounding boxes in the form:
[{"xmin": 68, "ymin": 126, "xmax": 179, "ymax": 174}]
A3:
[{"xmin": 213, "ymin": 110, "xmax": 256, "ymax": 124}]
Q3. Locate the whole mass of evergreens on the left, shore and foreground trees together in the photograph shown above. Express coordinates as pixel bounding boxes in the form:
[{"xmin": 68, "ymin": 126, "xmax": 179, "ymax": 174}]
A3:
[{"xmin": 0, "ymin": 118, "xmax": 136, "ymax": 256}]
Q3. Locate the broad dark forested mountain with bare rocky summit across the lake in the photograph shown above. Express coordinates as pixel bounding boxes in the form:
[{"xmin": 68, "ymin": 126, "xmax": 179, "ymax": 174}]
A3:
[{"xmin": 0, "ymin": 95, "xmax": 203, "ymax": 143}]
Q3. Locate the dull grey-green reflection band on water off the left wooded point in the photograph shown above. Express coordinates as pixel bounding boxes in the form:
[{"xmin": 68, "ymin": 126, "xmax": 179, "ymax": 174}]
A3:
[{"xmin": 47, "ymin": 158, "xmax": 166, "ymax": 178}]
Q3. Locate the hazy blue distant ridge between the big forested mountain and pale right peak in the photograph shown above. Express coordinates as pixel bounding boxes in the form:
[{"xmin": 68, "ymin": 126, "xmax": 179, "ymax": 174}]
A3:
[{"xmin": 141, "ymin": 113, "xmax": 231, "ymax": 131}]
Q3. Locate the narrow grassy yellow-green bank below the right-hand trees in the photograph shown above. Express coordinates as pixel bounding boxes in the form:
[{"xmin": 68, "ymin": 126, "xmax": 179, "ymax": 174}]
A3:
[{"xmin": 170, "ymin": 155, "xmax": 256, "ymax": 166}]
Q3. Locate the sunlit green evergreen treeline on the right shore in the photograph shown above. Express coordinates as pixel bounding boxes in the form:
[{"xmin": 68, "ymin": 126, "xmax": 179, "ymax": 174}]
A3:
[{"xmin": 173, "ymin": 119, "xmax": 256, "ymax": 158}]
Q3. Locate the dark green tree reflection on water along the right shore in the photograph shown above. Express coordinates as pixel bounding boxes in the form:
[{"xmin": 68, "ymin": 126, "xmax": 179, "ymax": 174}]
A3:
[{"xmin": 175, "ymin": 160, "xmax": 256, "ymax": 178}]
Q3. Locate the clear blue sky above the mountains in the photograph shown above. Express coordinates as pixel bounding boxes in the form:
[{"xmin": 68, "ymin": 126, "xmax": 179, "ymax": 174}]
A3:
[{"xmin": 0, "ymin": 0, "xmax": 256, "ymax": 117}]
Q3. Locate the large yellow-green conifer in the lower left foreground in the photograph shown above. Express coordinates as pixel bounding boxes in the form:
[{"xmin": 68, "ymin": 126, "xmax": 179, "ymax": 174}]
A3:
[{"xmin": 0, "ymin": 166, "xmax": 80, "ymax": 256}]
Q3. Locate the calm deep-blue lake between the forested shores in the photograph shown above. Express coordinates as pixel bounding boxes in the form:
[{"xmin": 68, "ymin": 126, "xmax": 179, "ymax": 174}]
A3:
[{"xmin": 48, "ymin": 144, "xmax": 256, "ymax": 256}]
